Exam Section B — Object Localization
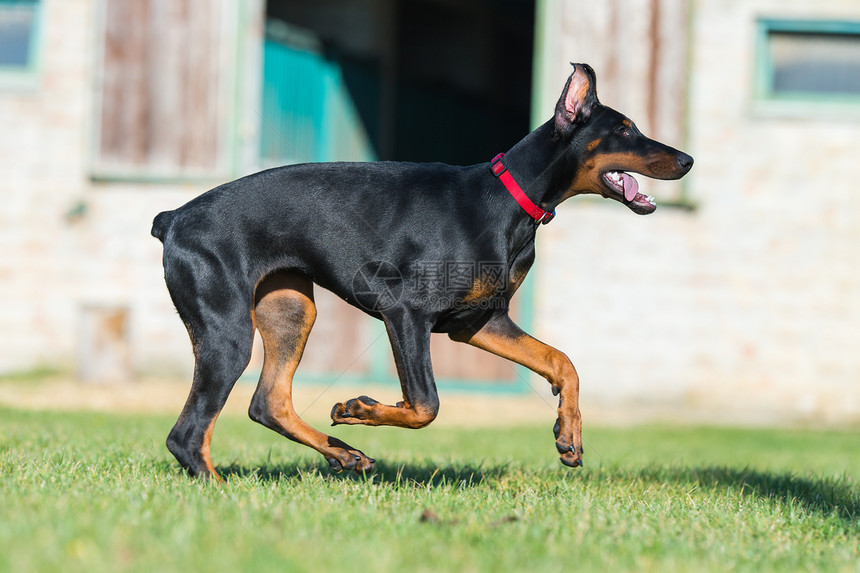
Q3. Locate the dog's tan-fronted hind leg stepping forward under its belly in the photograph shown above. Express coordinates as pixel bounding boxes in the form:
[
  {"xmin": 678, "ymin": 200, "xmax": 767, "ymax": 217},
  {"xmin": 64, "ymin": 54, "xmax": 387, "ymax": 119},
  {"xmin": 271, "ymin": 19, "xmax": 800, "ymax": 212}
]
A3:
[{"xmin": 248, "ymin": 273, "xmax": 374, "ymax": 473}]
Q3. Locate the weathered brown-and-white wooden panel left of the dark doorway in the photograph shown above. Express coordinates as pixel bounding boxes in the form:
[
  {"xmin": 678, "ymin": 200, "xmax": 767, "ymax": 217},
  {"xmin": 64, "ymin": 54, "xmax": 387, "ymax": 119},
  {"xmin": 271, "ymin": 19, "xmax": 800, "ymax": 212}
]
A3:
[{"xmin": 93, "ymin": 0, "xmax": 233, "ymax": 181}]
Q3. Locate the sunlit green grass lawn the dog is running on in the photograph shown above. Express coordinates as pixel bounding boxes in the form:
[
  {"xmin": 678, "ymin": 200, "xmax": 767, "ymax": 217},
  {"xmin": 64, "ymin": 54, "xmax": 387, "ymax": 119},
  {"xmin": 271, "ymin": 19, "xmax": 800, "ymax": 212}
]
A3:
[{"xmin": 0, "ymin": 410, "xmax": 860, "ymax": 573}]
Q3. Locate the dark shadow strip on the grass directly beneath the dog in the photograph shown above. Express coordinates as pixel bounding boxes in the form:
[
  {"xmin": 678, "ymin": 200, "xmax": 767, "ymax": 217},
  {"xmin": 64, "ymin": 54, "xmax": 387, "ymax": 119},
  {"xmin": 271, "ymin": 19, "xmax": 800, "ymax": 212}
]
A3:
[{"xmin": 218, "ymin": 460, "xmax": 508, "ymax": 487}]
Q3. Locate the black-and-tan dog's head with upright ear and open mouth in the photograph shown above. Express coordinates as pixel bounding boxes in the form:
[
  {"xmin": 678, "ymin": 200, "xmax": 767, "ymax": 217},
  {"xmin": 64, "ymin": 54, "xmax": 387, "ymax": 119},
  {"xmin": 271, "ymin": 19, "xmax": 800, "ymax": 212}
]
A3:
[{"xmin": 553, "ymin": 64, "xmax": 693, "ymax": 215}]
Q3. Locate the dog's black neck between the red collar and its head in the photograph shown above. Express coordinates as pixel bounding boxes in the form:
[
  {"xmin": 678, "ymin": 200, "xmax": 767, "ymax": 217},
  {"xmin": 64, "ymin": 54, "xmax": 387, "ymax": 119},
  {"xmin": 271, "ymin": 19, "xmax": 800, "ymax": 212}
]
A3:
[{"xmin": 498, "ymin": 120, "xmax": 576, "ymax": 212}]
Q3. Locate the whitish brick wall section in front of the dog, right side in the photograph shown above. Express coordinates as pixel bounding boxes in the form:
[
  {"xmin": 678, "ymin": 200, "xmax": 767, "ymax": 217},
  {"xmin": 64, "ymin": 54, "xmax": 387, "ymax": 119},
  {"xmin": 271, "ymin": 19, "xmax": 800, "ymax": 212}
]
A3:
[{"xmin": 536, "ymin": 0, "xmax": 860, "ymax": 422}]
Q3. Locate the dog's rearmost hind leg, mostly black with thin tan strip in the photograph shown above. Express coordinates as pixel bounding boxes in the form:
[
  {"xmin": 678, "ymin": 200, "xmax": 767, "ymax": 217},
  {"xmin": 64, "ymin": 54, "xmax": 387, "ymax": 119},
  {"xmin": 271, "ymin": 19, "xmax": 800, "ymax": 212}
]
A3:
[{"xmin": 167, "ymin": 309, "xmax": 254, "ymax": 479}]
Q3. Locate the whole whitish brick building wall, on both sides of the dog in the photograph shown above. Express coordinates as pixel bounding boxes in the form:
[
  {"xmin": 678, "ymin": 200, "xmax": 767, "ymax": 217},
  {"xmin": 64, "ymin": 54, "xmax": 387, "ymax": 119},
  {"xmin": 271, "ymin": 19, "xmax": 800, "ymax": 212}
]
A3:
[{"xmin": 0, "ymin": 0, "xmax": 860, "ymax": 422}]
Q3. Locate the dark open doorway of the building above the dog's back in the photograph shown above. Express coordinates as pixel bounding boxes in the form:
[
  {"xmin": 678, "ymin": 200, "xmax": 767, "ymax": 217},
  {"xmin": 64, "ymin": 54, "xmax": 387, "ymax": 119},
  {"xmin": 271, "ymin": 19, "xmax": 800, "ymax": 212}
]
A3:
[{"xmin": 264, "ymin": 0, "xmax": 535, "ymax": 165}]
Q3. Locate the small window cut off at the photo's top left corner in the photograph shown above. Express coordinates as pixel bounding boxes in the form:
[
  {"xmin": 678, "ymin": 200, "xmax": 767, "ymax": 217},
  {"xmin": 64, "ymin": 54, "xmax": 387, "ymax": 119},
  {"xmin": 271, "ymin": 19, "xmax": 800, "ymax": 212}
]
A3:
[{"xmin": 0, "ymin": 0, "xmax": 39, "ymax": 77}]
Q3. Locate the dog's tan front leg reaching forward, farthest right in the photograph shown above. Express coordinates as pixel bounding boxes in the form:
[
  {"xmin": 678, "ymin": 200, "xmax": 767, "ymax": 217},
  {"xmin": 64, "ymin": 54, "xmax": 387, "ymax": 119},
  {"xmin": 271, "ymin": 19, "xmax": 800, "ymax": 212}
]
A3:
[{"xmin": 449, "ymin": 311, "xmax": 582, "ymax": 467}]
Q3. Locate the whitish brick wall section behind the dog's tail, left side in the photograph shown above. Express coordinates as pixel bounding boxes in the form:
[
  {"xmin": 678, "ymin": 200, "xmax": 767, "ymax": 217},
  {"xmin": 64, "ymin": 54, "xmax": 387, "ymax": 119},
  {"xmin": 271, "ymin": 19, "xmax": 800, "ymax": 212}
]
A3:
[{"xmin": 0, "ymin": 0, "xmax": 206, "ymax": 373}]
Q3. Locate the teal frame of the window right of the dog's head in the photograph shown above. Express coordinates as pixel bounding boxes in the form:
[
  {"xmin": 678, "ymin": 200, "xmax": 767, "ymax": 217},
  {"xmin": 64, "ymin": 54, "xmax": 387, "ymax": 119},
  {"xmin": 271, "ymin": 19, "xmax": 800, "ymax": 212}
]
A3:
[{"xmin": 754, "ymin": 18, "xmax": 860, "ymax": 107}]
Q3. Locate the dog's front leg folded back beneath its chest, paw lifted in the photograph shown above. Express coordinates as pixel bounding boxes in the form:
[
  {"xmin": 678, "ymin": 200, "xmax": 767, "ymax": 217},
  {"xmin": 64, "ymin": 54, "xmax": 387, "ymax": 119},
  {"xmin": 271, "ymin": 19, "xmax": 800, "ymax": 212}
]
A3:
[{"xmin": 331, "ymin": 307, "xmax": 439, "ymax": 428}]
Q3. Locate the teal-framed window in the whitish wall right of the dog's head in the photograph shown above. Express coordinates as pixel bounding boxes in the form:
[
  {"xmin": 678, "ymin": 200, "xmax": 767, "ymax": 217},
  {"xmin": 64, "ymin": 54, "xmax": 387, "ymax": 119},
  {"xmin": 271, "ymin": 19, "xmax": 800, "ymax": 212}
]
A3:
[{"xmin": 757, "ymin": 20, "xmax": 860, "ymax": 104}]
